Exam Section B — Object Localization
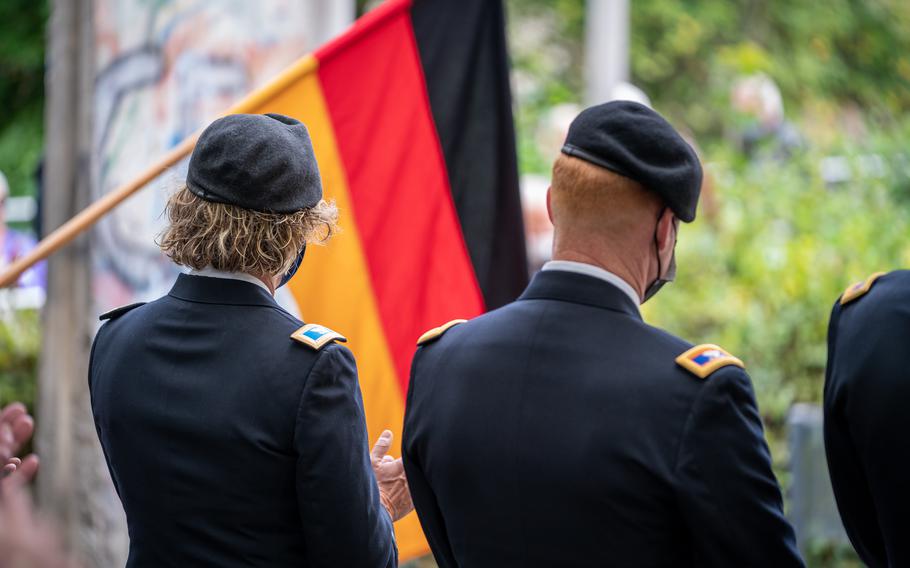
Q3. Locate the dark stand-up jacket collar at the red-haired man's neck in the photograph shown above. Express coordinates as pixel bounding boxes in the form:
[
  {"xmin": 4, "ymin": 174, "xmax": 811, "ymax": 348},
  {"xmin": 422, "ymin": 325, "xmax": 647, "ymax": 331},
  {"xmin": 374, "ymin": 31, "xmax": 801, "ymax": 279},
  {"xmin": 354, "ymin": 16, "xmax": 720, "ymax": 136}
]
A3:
[{"xmin": 518, "ymin": 269, "xmax": 642, "ymax": 320}]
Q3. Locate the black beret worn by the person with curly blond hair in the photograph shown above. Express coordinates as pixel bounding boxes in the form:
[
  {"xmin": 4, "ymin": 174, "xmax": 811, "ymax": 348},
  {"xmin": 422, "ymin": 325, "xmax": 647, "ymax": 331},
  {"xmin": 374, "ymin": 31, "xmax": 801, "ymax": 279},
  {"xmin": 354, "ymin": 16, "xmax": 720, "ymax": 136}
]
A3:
[{"xmin": 186, "ymin": 114, "xmax": 322, "ymax": 213}]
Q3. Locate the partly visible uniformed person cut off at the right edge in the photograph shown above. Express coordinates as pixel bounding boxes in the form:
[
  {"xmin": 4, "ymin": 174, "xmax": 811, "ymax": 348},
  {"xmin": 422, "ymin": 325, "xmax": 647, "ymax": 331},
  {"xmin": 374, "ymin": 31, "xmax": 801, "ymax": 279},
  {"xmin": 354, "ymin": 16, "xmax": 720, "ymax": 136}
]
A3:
[{"xmin": 824, "ymin": 270, "xmax": 910, "ymax": 568}]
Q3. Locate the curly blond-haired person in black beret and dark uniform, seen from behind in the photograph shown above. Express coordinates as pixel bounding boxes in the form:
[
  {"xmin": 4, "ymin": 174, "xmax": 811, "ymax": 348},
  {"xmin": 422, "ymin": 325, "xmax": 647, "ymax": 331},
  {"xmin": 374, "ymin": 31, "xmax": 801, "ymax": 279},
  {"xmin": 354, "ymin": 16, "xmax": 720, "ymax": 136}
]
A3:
[{"xmin": 89, "ymin": 114, "xmax": 410, "ymax": 568}]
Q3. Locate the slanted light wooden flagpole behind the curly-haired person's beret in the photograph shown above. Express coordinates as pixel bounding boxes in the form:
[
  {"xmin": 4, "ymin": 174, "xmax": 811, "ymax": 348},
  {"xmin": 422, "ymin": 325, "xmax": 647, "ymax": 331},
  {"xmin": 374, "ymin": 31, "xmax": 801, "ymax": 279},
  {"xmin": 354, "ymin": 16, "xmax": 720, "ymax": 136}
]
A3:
[{"xmin": 0, "ymin": 54, "xmax": 318, "ymax": 288}]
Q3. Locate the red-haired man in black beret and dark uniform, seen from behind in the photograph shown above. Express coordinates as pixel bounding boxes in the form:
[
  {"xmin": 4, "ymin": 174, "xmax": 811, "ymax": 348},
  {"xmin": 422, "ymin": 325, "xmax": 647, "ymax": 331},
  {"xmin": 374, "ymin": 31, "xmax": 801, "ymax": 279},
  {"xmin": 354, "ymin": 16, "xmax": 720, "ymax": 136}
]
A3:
[{"xmin": 403, "ymin": 102, "xmax": 802, "ymax": 568}]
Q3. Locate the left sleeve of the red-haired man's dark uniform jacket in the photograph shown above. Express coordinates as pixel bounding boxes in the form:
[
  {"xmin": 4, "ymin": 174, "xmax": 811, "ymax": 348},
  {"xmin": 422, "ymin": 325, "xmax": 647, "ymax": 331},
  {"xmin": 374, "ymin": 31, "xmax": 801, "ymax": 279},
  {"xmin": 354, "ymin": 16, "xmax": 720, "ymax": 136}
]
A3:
[{"xmin": 401, "ymin": 350, "xmax": 458, "ymax": 568}]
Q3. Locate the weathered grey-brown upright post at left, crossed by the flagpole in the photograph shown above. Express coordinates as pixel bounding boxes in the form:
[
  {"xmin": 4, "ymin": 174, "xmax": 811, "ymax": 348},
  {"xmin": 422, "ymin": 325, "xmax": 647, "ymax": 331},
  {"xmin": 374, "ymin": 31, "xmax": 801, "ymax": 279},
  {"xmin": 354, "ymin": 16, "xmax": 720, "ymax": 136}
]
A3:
[{"xmin": 36, "ymin": 0, "xmax": 128, "ymax": 568}]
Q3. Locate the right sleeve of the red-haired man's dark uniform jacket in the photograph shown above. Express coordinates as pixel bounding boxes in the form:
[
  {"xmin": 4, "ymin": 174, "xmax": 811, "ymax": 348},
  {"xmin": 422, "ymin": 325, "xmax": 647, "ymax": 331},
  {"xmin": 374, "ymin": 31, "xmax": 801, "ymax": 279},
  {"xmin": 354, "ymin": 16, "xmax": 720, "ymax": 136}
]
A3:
[{"xmin": 676, "ymin": 367, "xmax": 803, "ymax": 568}]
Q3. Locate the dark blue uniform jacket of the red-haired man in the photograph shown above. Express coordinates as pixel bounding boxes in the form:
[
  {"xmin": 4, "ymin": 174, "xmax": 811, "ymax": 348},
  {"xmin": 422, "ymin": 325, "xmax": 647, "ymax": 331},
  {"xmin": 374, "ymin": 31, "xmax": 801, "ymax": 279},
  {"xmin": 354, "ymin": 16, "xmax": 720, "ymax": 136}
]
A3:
[{"xmin": 403, "ymin": 271, "xmax": 802, "ymax": 568}]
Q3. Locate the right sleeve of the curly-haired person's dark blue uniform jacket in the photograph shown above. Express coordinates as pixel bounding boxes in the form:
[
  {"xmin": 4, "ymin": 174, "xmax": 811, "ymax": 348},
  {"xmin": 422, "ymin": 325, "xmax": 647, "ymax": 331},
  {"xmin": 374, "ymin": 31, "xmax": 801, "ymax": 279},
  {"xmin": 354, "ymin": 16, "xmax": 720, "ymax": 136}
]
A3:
[{"xmin": 294, "ymin": 345, "xmax": 398, "ymax": 568}]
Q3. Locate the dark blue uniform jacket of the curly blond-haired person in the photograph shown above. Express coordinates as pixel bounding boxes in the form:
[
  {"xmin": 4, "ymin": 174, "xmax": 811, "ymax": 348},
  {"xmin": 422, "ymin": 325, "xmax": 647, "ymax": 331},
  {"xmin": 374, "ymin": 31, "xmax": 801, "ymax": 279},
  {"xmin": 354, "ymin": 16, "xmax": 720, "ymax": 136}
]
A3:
[{"xmin": 89, "ymin": 275, "xmax": 397, "ymax": 568}]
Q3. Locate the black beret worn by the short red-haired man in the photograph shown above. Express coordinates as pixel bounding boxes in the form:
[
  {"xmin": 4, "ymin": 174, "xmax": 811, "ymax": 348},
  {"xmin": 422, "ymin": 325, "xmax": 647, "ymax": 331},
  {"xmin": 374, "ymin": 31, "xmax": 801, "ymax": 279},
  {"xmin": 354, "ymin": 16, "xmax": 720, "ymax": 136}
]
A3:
[{"xmin": 562, "ymin": 101, "xmax": 702, "ymax": 223}]
